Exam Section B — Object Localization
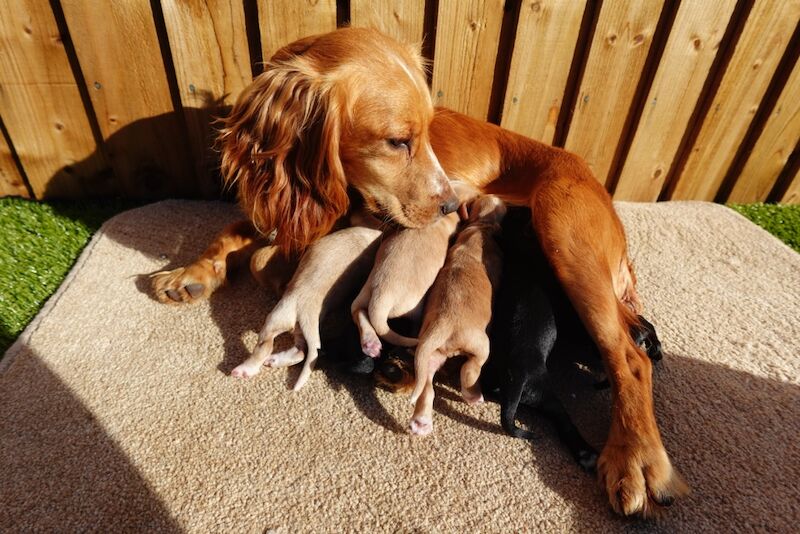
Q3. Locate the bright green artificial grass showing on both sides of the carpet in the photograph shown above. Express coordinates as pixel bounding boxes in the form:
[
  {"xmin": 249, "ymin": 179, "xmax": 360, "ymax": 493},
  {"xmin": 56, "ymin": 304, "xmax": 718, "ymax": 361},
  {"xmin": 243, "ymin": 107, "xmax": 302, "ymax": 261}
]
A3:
[{"xmin": 0, "ymin": 198, "xmax": 800, "ymax": 357}]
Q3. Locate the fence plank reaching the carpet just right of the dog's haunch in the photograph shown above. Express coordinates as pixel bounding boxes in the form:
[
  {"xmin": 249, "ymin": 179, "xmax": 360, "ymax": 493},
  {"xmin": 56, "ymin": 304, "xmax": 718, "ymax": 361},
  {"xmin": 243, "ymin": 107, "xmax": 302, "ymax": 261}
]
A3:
[{"xmin": 614, "ymin": 0, "xmax": 736, "ymax": 201}]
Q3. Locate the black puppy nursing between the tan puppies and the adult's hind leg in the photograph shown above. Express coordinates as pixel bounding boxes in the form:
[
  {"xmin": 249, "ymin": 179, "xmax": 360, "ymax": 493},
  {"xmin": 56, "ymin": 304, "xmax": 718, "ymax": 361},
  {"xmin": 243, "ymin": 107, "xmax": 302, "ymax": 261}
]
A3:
[{"xmin": 481, "ymin": 208, "xmax": 661, "ymax": 471}]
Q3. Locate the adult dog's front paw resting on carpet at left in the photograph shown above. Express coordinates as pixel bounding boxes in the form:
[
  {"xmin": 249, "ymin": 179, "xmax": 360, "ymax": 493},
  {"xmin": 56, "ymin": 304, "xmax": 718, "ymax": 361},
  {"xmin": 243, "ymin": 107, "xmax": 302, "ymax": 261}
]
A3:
[{"xmin": 150, "ymin": 261, "xmax": 225, "ymax": 304}]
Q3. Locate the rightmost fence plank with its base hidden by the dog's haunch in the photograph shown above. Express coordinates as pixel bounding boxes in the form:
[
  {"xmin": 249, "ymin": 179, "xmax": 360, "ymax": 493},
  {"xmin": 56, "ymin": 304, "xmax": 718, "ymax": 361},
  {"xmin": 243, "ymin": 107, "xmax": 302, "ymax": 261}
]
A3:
[{"xmin": 565, "ymin": 0, "xmax": 664, "ymax": 184}]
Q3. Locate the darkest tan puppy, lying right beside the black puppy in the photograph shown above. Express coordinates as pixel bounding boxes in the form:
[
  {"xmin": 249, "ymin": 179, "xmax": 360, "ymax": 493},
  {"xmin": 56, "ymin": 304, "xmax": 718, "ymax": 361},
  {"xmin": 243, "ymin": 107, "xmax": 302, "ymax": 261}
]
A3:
[{"xmin": 411, "ymin": 195, "xmax": 506, "ymax": 435}]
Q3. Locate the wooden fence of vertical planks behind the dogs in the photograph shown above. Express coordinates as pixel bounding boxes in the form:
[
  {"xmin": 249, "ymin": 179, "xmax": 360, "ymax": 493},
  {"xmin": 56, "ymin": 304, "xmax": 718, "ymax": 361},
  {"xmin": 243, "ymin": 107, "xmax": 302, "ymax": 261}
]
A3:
[{"xmin": 0, "ymin": 0, "xmax": 800, "ymax": 203}]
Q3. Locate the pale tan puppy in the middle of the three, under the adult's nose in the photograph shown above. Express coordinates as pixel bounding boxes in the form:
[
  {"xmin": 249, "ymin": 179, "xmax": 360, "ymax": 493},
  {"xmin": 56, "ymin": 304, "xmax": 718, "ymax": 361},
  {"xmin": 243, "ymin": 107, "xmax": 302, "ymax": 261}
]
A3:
[{"xmin": 350, "ymin": 182, "xmax": 477, "ymax": 358}]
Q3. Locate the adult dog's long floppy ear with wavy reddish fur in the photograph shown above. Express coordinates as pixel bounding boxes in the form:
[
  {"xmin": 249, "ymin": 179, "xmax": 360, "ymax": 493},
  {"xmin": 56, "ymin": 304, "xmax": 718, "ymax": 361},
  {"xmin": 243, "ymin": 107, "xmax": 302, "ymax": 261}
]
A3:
[{"xmin": 219, "ymin": 56, "xmax": 348, "ymax": 252}]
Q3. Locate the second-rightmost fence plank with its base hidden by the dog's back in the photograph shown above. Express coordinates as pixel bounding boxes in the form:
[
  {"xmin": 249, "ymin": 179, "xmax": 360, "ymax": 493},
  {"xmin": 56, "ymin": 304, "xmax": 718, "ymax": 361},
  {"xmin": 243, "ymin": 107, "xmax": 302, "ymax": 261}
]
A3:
[{"xmin": 501, "ymin": 0, "xmax": 586, "ymax": 143}]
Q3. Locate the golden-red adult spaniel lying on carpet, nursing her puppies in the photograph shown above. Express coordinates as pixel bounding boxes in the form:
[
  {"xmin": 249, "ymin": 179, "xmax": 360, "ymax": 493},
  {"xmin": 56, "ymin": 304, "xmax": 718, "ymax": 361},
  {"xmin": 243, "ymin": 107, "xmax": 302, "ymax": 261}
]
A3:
[{"xmin": 153, "ymin": 28, "xmax": 688, "ymax": 516}]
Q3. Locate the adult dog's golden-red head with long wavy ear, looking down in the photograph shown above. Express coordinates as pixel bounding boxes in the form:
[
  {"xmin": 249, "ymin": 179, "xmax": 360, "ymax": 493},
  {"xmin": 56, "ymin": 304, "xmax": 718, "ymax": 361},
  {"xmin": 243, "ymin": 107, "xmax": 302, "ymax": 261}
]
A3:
[{"xmin": 220, "ymin": 28, "xmax": 458, "ymax": 254}]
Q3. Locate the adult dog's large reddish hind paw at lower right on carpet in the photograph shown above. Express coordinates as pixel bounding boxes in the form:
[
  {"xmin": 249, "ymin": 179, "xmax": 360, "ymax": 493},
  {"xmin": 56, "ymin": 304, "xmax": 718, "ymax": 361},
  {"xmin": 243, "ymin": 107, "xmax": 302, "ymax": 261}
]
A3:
[{"xmin": 597, "ymin": 443, "xmax": 689, "ymax": 518}]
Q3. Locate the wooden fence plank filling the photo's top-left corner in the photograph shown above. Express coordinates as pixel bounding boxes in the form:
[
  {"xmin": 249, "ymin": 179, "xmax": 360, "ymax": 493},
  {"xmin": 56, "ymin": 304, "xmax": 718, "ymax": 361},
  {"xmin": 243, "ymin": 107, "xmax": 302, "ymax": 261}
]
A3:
[{"xmin": 0, "ymin": 0, "xmax": 105, "ymax": 198}]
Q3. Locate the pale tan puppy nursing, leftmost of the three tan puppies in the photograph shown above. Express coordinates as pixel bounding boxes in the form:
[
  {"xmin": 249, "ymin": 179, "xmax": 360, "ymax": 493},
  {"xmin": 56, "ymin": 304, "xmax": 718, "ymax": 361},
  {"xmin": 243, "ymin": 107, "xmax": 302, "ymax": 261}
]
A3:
[{"xmin": 231, "ymin": 214, "xmax": 381, "ymax": 391}]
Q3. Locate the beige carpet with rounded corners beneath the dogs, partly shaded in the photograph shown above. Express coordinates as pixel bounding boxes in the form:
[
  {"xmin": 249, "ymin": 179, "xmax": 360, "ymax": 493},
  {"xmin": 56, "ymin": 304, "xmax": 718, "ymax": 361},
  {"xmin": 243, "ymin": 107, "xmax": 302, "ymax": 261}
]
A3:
[{"xmin": 0, "ymin": 201, "xmax": 800, "ymax": 532}]
